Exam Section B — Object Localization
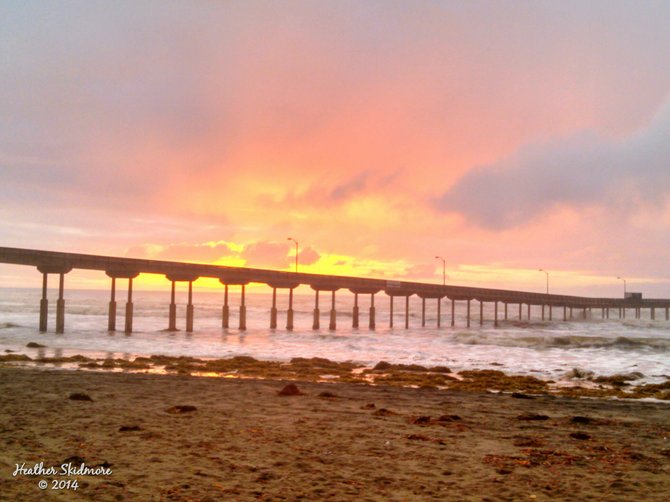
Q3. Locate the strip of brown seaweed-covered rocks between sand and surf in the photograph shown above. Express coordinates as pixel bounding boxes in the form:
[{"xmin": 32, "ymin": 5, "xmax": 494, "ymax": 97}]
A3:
[{"xmin": 0, "ymin": 352, "xmax": 670, "ymax": 403}]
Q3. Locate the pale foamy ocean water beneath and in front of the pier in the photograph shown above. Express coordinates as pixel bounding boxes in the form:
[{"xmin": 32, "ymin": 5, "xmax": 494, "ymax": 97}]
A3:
[{"xmin": 0, "ymin": 288, "xmax": 670, "ymax": 383}]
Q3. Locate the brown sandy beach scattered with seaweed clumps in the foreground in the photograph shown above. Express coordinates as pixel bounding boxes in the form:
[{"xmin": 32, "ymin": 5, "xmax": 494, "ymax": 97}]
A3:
[{"xmin": 0, "ymin": 367, "xmax": 670, "ymax": 501}]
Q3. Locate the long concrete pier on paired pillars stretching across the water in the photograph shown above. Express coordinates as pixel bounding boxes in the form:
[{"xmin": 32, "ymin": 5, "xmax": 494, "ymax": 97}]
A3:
[{"xmin": 0, "ymin": 247, "xmax": 670, "ymax": 333}]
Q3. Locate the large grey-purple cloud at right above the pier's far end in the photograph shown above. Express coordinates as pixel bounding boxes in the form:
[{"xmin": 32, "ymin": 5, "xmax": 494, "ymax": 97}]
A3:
[{"xmin": 435, "ymin": 96, "xmax": 670, "ymax": 230}]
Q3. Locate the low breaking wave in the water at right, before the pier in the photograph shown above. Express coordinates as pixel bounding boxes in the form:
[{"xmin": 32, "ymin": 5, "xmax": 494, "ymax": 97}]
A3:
[{"xmin": 453, "ymin": 332, "xmax": 670, "ymax": 350}]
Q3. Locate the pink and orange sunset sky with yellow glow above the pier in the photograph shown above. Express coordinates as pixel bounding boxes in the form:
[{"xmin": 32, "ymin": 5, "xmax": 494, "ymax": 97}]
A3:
[{"xmin": 0, "ymin": 0, "xmax": 670, "ymax": 298}]
